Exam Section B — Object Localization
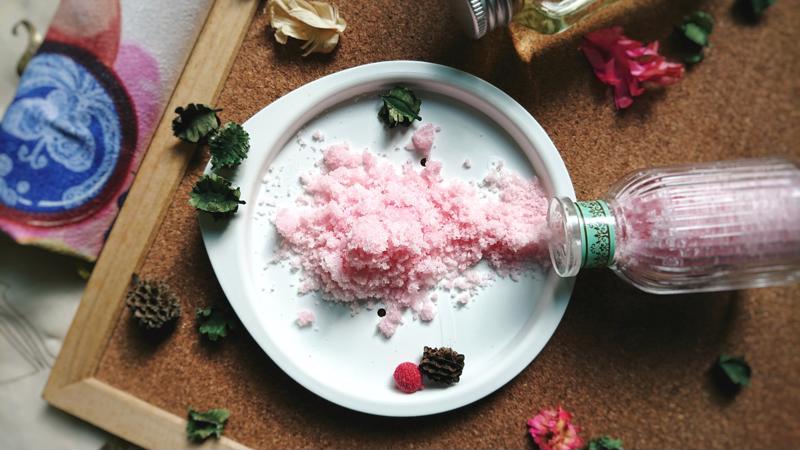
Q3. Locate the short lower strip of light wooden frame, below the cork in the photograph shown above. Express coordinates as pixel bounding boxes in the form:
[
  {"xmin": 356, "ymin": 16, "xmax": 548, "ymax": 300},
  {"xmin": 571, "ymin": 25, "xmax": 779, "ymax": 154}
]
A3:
[{"xmin": 46, "ymin": 378, "xmax": 248, "ymax": 450}]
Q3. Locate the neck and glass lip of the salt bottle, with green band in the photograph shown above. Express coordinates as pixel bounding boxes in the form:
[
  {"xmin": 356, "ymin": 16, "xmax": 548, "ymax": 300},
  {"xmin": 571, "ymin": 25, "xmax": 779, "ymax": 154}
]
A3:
[{"xmin": 547, "ymin": 197, "xmax": 616, "ymax": 277}]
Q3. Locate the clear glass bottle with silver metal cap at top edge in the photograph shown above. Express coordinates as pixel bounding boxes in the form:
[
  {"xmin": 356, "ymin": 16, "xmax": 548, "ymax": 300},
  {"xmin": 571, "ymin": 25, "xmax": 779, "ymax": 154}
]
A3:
[{"xmin": 450, "ymin": 0, "xmax": 616, "ymax": 39}]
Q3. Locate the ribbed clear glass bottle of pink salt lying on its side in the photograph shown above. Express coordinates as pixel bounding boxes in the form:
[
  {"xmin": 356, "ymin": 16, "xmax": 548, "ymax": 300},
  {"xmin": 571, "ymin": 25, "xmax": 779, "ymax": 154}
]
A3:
[{"xmin": 548, "ymin": 158, "xmax": 800, "ymax": 294}]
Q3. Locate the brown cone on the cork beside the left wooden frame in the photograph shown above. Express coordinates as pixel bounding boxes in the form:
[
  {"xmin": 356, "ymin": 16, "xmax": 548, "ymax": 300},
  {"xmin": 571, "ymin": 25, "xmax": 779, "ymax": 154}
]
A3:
[{"xmin": 125, "ymin": 279, "xmax": 181, "ymax": 330}]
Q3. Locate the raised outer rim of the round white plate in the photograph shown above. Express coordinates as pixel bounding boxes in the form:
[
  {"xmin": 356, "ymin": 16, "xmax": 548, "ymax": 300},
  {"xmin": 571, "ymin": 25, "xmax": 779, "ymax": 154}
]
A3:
[{"xmin": 199, "ymin": 60, "xmax": 575, "ymax": 417}]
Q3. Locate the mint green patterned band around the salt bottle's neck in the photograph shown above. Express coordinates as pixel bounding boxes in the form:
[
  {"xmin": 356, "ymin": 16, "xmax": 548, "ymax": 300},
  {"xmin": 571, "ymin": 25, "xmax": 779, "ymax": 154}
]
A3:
[{"xmin": 575, "ymin": 200, "xmax": 616, "ymax": 267}]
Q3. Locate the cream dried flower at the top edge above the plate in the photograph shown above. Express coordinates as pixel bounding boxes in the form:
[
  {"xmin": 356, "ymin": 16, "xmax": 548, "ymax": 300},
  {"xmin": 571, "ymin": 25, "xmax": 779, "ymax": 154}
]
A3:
[{"xmin": 269, "ymin": 0, "xmax": 347, "ymax": 56}]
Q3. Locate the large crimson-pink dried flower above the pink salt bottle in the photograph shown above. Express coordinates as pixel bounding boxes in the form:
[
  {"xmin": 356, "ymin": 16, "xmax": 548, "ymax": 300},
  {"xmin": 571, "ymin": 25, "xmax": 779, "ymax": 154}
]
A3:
[{"xmin": 580, "ymin": 27, "xmax": 684, "ymax": 109}]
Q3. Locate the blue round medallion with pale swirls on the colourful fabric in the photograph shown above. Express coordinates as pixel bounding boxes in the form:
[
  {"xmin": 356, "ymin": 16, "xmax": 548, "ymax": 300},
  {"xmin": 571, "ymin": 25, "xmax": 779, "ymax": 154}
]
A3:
[{"xmin": 0, "ymin": 53, "xmax": 122, "ymax": 213}]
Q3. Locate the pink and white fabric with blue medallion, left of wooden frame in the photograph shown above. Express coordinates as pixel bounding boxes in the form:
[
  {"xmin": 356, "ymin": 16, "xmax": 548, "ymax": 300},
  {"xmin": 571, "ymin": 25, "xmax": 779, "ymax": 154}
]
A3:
[{"xmin": 0, "ymin": 0, "xmax": 213, "ymax": 260}]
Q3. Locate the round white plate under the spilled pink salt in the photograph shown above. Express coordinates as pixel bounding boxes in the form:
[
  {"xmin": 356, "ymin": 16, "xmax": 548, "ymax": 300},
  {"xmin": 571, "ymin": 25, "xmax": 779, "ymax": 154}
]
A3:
[{"xmin": 201, "ymin": 61, "xmax": 574, "ymax": 416}]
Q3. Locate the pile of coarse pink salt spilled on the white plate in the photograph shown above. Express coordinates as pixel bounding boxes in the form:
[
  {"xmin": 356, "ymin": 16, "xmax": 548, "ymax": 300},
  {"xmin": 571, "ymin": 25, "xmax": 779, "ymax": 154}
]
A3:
[{"xmin": 275, "ymin": 145, "xmax": 547, "ymax": 337}]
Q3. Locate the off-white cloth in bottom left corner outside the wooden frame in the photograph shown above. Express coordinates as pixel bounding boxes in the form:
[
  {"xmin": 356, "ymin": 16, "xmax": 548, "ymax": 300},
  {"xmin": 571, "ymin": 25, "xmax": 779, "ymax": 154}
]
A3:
[{"xmin": 0, "ymin": 236, "xmax": 108, "ymax": 450}]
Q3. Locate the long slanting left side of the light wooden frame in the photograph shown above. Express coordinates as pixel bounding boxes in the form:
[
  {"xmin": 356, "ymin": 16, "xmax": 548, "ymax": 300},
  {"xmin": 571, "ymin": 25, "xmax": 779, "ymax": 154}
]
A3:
[{"xmin": 43, "ymin": 0, "xmax": 259, "ymax": 398}]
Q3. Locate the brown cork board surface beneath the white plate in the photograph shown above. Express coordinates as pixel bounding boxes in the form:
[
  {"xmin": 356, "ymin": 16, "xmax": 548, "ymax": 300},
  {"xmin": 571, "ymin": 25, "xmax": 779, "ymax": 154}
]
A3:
[{"xmin": 96, "ymin": 0, "xmax": 800, "ymax": 448}]
